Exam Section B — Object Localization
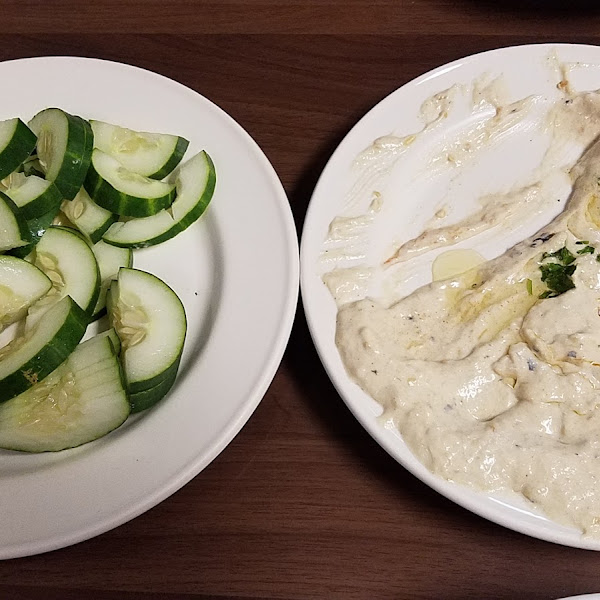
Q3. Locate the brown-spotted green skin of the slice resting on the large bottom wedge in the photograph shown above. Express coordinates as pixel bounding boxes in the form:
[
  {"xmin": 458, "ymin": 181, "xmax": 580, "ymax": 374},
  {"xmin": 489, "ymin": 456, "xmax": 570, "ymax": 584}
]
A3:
[{"xmin": 0, "ymin": 296, "xmax": 89, "ymax": 402}]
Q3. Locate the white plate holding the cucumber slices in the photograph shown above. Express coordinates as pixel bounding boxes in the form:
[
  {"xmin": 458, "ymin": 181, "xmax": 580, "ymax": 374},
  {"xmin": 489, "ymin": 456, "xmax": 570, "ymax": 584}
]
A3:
[{"xmin": 0, "ymin": 57, "xmax": 298, "ymax": 558}]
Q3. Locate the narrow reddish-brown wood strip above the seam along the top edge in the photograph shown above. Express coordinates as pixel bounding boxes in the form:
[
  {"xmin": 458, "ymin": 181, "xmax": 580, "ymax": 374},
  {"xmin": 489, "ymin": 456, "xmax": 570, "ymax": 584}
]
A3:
[{"xmin": 2, "ymin": 0, "xmax": 600, "ymax": 36}]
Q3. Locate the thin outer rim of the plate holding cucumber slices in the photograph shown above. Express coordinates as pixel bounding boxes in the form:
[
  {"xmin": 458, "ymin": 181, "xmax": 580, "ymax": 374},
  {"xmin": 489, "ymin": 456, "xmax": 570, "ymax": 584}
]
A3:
[{"xmin": 0, "ymin": 55, "xmax": 300, "ymax": 560}]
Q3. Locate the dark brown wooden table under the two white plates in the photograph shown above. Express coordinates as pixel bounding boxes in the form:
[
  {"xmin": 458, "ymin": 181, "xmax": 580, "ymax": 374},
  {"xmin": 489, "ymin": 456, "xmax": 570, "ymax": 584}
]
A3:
[{"xmin": 0, "ymin": 0, "xmax": 600, "ymax": 600}]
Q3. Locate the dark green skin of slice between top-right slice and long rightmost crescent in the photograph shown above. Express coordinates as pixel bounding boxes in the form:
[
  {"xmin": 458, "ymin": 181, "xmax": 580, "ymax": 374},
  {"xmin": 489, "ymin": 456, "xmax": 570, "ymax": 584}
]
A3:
[{"xmin": 83, "ymin": 164, "xmax": 175, "ymax": 217}]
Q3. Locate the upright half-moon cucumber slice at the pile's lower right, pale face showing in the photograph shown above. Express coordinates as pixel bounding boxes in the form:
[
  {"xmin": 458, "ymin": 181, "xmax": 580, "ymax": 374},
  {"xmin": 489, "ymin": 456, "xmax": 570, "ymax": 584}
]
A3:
[{"xmin": 107, "ymin": 268, "xmax": 187, "ymax": 394}]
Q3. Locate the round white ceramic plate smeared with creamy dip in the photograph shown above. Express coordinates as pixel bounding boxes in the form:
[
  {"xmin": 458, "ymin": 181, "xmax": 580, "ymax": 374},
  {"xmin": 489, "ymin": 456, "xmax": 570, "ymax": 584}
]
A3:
[{"xmin": 300, "ymin": 45, "xmax": 600, "ymax": 549}]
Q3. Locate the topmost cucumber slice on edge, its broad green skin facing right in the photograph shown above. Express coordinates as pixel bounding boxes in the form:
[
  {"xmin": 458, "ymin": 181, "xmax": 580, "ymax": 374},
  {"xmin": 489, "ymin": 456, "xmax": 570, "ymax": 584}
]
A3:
[{"xmin": 29, "ymin": 108, "xmax": 94, "ymax": 200}]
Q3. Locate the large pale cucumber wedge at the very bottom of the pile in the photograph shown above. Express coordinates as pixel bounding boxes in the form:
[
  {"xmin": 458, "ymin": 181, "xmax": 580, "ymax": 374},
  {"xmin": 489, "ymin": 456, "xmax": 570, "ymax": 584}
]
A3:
[{"xmin": 0, "ymin": 335, "xmax": 130, "ymax": 452}]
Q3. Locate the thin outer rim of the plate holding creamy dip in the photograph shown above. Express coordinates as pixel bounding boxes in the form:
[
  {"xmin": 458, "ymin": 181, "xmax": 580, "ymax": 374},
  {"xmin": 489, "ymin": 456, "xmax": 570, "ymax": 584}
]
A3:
[{"xmin": 300, "ymin": 42, "xmax": 600, "ymax": 551}]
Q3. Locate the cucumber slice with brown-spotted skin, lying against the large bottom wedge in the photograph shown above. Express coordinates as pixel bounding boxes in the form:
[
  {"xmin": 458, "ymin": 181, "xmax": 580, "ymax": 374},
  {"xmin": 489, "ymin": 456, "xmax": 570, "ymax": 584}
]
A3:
[{"xmin": 0, "ymin": 296, "xmax": 89, "ymax": 402}]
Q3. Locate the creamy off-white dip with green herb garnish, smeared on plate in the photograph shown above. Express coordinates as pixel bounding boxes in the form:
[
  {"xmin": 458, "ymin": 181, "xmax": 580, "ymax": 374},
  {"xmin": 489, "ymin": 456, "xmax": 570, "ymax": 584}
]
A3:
[{"xmin": 324, "ymin": 68, "xmax": 600, "ymax": 536}]
